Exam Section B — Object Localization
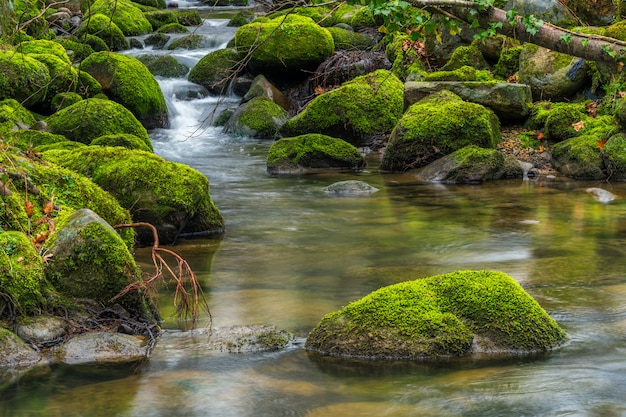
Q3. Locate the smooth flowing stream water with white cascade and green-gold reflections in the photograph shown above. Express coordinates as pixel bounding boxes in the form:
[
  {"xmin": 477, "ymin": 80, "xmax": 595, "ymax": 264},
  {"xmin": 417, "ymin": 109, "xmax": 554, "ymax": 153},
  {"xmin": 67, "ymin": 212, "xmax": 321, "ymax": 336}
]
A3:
[{"xmin": 0, "ymin": 6, "xmax": 626, "ymax": 417}]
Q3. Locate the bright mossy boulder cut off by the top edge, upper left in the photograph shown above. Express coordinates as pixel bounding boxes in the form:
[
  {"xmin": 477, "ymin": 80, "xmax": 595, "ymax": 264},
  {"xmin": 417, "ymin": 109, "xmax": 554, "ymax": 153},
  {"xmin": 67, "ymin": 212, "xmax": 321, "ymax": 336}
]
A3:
[{"xmin": 84, "ymin": 0, "xmax": 152, "ymax": 36}]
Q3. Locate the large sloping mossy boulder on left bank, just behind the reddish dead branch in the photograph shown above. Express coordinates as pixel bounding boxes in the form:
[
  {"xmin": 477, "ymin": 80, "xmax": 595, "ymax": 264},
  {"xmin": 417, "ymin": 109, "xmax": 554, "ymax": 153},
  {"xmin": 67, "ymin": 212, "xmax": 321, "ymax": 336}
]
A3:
[{"xmin": 44, "ymin": 146, "xmax": 224, "ymax": 244}]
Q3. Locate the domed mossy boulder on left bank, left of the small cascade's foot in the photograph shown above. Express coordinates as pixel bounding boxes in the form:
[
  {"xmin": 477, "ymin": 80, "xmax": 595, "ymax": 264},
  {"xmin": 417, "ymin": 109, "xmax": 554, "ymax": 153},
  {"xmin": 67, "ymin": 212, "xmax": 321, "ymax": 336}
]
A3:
[{"xmin": 46, "ymin": 98, "xmax": 152, "ymax": 149}]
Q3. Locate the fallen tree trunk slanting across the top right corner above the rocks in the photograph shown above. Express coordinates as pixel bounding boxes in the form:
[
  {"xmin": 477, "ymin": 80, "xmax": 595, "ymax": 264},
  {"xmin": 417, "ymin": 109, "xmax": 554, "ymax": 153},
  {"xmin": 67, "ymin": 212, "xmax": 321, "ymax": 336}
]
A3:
[{"xmin": 409, "ymin": 0, "xmax": 626, "ymax": 66}]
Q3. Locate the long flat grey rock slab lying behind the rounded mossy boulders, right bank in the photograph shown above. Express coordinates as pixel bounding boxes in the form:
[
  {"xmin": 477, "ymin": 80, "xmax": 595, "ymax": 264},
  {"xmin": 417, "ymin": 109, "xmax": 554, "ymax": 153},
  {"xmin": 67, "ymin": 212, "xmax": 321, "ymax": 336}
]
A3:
[{"xmin": 404, "ymin": 81, "xmax": 533, "ymax": 120}]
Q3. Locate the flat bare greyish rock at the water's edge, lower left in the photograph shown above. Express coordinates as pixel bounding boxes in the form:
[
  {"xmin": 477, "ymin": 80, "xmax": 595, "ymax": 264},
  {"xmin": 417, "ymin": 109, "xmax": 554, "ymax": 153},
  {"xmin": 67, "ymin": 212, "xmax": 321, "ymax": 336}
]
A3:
[{"xmin": 55, "ymin": 332, "xmax": 148, "ymax": 364}]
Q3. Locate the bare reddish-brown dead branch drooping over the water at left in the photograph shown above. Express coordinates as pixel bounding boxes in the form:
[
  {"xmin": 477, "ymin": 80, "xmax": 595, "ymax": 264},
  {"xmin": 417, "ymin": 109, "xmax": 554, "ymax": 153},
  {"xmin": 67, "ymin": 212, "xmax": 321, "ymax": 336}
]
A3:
[{"xmin": 112, "ymin": 222, "xmax": 213, "ymax": 327}]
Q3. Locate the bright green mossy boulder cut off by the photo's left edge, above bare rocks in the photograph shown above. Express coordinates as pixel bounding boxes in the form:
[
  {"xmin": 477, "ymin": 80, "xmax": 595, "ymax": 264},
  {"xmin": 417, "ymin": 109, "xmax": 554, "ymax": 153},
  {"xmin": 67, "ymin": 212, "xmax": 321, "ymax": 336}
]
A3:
[{"xmin": 0, "ymin": 231, "xmax": 52, "ymax": 317}]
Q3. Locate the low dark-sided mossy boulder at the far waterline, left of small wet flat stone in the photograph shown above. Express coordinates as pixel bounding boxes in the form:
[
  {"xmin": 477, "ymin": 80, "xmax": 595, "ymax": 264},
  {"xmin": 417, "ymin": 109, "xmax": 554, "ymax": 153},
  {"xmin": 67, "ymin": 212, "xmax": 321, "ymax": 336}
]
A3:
[{"xmin": 267, "ymin": 133, "xmax": 365, "ymax": 175}]
